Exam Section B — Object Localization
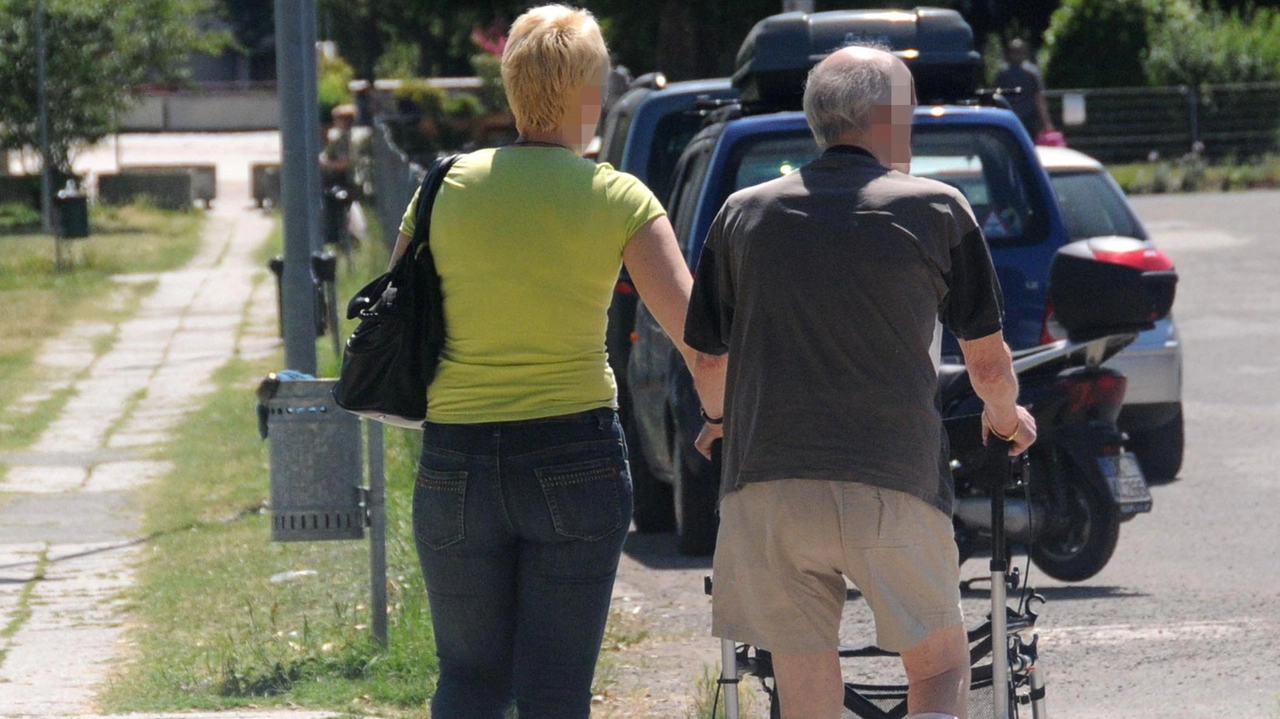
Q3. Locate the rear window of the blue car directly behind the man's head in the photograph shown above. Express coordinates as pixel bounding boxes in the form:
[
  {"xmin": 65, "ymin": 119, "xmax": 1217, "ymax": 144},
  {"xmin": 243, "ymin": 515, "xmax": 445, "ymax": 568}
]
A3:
[{"xmin": 721, "ymin": 125, "xmax": 1048, "ymax": 244}]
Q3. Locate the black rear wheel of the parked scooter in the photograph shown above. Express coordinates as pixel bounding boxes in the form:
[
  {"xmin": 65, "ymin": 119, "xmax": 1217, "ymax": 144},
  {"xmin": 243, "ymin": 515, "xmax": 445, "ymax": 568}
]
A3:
[{"xmin": 1032, "ymin": 457, "xmax": 1120, "ymax": 582}]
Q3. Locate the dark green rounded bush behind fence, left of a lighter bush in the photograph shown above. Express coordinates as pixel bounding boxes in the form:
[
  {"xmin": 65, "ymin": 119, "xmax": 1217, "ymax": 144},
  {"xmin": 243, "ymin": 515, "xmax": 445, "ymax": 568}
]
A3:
[{"xmin": 1041, "ymin": 0, "xmax": 1196, "ymax": 87}]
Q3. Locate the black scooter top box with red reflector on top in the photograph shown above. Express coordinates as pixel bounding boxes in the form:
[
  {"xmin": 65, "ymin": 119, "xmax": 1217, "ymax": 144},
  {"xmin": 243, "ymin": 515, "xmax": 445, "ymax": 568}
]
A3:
[{"xmin": 1048, "ymin": 237, "xmax": 1178, "ymax": 342}]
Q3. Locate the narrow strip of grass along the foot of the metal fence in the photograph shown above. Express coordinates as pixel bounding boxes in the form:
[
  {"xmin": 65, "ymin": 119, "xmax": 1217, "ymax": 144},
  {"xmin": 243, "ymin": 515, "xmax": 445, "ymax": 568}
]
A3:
[{"xmin": 1107, "ymin": 155, "xmax": 1280, "ymax": 194}]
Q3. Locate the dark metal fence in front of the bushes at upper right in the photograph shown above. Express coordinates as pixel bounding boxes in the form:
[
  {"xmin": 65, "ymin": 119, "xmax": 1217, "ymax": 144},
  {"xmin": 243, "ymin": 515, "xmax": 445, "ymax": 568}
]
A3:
[{"xmin": 1044, "ymin": 83, "xmax": 1280, "ymax": 162}]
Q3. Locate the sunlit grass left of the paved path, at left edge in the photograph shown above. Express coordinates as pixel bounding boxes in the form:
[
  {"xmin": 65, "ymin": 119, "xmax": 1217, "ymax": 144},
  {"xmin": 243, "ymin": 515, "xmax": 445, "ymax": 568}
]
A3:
[{"xmin": 0, "ymin": 206, "xmax": 202, "ymax": 450}]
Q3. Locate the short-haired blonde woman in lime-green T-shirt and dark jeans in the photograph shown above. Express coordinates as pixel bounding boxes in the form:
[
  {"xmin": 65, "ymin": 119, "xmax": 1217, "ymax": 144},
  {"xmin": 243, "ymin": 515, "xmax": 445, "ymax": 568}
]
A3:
[{"xmin": 396, "ymin": 5, "xmax": 692, "ymax": 719}]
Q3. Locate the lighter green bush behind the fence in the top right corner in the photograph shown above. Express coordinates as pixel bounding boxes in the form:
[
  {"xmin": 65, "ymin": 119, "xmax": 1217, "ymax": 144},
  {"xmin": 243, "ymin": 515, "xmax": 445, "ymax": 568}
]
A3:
[{"xmin": 1146, "ymin": 8, "xmax": 1280, "ymax": 86}]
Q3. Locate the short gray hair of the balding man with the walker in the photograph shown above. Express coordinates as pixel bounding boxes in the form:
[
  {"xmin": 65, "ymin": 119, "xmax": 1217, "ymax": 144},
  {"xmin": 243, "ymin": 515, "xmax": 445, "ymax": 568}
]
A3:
[{"xmin": 804, "ymin": 43, "xmax": 893, "ymax": 150}]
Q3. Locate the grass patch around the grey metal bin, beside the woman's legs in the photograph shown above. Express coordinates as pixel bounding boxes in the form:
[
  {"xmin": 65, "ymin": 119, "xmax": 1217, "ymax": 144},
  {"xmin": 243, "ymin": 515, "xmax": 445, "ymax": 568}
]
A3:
[{"xmin": 102, "ymin": 347, "xmax": 435, "ymax": 716}]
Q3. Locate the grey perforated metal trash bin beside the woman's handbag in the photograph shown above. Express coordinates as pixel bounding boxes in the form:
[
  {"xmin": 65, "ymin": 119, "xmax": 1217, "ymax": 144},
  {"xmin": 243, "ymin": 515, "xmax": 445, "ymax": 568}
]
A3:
[{"xmin": 265, "ymin": 380, "xmax": 366, "ymax": 541}]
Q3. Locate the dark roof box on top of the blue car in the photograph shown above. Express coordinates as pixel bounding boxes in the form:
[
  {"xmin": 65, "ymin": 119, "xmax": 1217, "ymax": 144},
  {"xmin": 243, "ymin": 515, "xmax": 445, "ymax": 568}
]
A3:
[{"xmin": 733, "ymin": 8, "xmax": 983, "ymax": 110}]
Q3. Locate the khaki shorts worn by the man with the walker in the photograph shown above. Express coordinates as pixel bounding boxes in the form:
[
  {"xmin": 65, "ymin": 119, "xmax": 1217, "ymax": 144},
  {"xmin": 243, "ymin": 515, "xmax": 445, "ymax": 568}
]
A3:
[{"xmin": 712, "ymin": 480, "xmax": 964, "ymax": 654}]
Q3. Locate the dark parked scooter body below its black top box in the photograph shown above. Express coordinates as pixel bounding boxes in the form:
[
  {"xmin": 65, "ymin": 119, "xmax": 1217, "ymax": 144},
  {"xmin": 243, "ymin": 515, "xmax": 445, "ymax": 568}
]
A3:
[{"xmin": 938, "ymin": 333, "xmax": 1152, "ymax": 582}]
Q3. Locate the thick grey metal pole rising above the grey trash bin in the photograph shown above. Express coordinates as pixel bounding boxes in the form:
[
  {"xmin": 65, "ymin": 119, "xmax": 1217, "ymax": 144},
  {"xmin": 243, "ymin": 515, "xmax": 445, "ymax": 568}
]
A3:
[{"xmin": 275, "ymin": 0, "xmax": 319, "ymax": 375}]
